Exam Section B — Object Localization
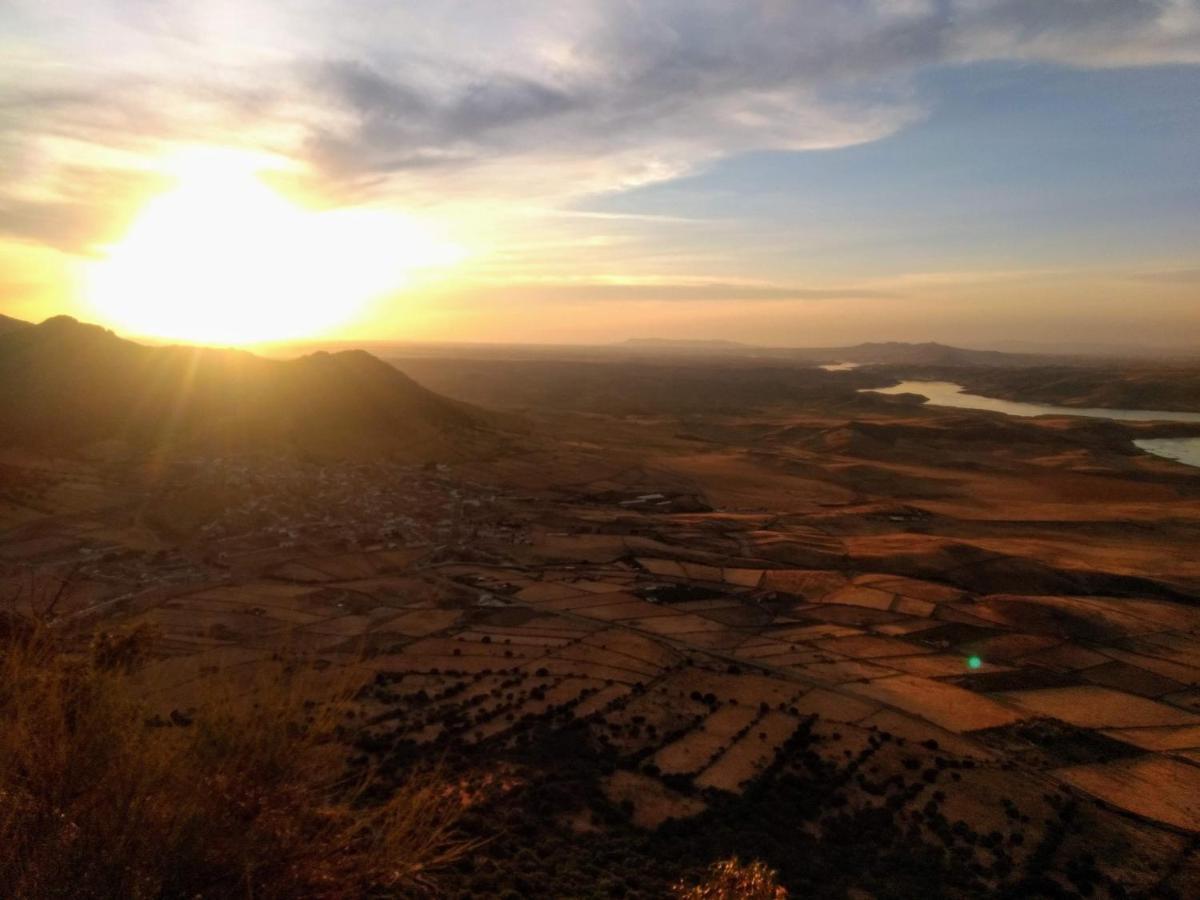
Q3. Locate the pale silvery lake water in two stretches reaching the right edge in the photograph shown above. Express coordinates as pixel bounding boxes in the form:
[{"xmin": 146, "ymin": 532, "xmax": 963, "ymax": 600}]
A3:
[{"xmin": 863, "ymin": 382, "xmax": 1200, "ymax": 467}]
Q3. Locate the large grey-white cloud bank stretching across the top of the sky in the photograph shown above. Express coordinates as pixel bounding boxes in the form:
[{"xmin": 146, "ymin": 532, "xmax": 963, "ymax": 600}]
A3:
[{"xmin": 0, "ymin": 0, "xmax": 1200, "ymax": 247}]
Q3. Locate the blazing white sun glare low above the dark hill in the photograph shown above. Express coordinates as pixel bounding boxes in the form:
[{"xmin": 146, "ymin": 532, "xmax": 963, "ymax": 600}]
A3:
[{"xmin": 86, "ymin": 150, "xmax": 463, "ymax": 344}]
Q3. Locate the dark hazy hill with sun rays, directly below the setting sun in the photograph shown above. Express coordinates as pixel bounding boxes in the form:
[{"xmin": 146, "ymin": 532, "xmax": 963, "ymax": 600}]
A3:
[{"xmin": 0, "ymin": 317, "xmax": 494, "ymax": 461}]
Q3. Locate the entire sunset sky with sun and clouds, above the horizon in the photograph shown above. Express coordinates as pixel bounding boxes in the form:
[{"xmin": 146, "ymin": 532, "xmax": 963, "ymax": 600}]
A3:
[{"xmin": 0, "ymin": 0, "xmax": 1200, "ymax": 349}]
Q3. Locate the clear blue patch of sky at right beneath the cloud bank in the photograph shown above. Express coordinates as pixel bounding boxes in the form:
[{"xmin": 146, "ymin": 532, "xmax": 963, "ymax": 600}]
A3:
[{"xmin": 588, "ymin": 62, "xmax": 1200, "ymax": 275}]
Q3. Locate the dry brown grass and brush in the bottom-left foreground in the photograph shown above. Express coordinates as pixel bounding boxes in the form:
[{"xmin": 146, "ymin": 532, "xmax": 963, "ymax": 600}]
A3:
[{"xmin": 0, "ymin": 592, "xmax": 470, "ymax": 899}]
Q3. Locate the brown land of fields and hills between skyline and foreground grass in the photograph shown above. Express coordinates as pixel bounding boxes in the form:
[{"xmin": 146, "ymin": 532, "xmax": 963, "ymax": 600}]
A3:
[{"xmin": 0, "ymin": 320, "xmax": 1200, "ymax": 898}]
